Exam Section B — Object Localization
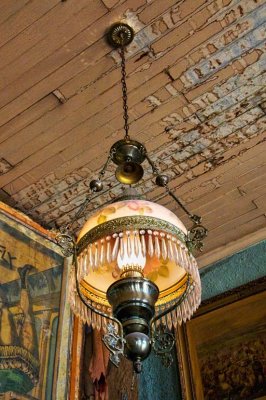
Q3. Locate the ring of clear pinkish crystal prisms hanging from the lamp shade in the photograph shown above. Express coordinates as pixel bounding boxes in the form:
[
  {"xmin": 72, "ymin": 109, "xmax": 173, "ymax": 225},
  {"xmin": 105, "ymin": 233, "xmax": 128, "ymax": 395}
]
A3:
[{"xmin": 69, "ymin": 230, "xmax": 201, "ymax": 330}]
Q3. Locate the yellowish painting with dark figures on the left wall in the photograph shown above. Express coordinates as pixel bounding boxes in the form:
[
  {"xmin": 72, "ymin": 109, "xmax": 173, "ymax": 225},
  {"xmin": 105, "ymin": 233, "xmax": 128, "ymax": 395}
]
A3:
[{"xmin": 0, "ymin": 206, "xmax": 64, "ymax": 400}]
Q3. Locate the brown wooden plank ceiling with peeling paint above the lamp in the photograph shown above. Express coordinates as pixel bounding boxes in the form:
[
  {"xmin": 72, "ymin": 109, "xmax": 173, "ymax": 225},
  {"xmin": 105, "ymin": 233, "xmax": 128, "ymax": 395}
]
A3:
[{"xmin": 0, "ymin": 0, "xmax": 266, "ymax": 260}]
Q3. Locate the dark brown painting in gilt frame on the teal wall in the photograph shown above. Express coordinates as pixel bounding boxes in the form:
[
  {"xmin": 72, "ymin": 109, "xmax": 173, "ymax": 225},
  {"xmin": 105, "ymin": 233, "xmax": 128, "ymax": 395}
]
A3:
[{"xmin": 177, "ymin": 278, "xmax": 266, "ymax": 400}]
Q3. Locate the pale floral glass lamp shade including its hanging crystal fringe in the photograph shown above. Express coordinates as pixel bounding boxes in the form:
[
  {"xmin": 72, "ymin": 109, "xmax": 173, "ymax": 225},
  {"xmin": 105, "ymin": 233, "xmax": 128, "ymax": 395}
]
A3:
[{"xmin": 70, "ymin": 200, "xmax": 201, "ymax": 329}]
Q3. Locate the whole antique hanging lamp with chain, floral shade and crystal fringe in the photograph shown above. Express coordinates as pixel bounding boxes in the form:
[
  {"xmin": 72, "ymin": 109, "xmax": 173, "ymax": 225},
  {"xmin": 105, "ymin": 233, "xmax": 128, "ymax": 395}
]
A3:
[{"xmin": 57, "ymin": 23, "xmax": 207, "ymax": 373}]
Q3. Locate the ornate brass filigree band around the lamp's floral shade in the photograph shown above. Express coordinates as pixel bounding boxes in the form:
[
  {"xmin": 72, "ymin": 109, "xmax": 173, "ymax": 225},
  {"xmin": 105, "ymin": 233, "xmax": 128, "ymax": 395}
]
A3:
[{"xmin": 77, "ymin": 215, "xmax": 187, "ymax": 254}]
